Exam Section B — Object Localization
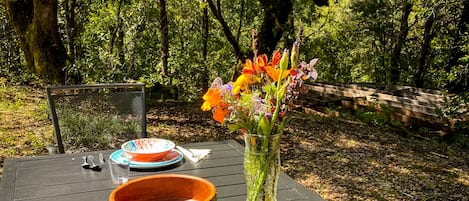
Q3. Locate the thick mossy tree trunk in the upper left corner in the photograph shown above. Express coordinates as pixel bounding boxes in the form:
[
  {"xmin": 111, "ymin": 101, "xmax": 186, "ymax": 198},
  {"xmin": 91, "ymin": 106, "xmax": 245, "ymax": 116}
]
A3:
[{"xmin": 4, "ymin": 0, "xmax": 66, "ymax": 83}]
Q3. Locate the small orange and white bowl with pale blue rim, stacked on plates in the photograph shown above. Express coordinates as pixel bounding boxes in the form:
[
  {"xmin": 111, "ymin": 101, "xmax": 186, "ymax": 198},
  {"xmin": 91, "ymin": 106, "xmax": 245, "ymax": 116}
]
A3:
[{"xmin": 121, "ymin": 138, "xmax": 176, "ymax": 162}]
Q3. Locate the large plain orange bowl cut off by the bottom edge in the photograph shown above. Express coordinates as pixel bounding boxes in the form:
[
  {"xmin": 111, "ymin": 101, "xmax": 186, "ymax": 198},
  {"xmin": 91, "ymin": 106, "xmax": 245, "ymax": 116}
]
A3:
[{"xmin": 109, "ymin": 174, "xmax": 216, "ymax": 201}]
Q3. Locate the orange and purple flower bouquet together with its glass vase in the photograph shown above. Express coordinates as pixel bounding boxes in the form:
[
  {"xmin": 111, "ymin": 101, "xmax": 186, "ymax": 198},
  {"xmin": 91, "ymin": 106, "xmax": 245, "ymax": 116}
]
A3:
[{"xmin": 201, "ymin": 31, "xmax": 318, "ymax": 201}]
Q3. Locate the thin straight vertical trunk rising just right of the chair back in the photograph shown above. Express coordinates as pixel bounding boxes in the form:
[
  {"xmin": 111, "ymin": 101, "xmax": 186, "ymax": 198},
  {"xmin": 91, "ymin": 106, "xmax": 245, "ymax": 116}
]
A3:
[{"xmin": 158, "ymin": 0, "xmax": 169, "ymax": 77}]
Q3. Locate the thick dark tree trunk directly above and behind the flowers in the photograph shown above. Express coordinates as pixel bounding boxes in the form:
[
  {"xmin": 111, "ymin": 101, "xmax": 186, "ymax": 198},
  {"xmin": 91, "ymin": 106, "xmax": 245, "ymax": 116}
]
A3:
[{"xmin": 257, "ymin": 0, "xmax": 293, "ymax": 54}]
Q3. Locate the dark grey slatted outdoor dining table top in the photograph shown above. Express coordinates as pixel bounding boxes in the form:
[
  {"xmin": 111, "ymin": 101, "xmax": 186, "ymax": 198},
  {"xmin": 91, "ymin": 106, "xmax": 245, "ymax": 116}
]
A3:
[{"xmin": 0, "ymin": 140, "xmax": 323, "ymax": 201}]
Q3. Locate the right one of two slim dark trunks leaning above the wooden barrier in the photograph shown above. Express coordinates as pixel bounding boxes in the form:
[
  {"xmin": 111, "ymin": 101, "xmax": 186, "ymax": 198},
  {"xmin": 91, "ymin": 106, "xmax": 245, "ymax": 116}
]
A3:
[{"xmin": 415, "ymin": 10, "xmax": 435, "ymax": 87}]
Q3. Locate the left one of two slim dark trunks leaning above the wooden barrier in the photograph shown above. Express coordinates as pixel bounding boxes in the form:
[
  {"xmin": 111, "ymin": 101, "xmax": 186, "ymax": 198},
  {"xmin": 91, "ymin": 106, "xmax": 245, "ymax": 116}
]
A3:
[{"xmin": 390, "ymin": 0, "xmax": 412, "ymax": 84}]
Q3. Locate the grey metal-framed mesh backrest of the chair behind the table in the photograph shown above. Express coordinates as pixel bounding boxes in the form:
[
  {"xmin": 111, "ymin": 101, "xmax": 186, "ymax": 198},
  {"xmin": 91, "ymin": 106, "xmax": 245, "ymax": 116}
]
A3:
[{"xmin": 46, "ymin": 83, "xmax": 147, "ymax": 153}]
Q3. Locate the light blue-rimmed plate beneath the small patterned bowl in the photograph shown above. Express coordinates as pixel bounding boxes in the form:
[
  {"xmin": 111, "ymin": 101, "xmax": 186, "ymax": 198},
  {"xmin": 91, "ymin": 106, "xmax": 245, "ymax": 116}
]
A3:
[{"xmin": 109, "ymin": 149, "xmax": 184, "ymax": 169}]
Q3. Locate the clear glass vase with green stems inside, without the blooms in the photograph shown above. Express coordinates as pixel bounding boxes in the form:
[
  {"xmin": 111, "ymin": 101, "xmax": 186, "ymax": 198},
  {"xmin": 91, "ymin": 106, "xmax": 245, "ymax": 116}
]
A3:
[{"xmin": 244, "ymin": 134, "xmax": 281, "ymax": 201}]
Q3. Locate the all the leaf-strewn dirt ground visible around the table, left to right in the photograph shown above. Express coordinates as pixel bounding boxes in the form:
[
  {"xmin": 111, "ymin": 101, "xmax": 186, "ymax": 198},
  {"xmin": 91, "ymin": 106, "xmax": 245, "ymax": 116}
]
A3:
[{"xmin": 0, "ymin": 90, "xmax": 469, "ymax": 201}]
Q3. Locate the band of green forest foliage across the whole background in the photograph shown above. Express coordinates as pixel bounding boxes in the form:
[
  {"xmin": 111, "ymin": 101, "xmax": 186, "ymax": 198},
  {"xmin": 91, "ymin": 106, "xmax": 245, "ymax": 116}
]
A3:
[{"xmin": 0, "ymin": 0, "xmax": 469, "ymax": 100}]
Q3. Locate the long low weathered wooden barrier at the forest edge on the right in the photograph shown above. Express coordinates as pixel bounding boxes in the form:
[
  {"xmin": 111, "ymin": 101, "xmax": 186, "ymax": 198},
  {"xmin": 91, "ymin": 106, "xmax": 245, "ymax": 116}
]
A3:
[{"xmin": 302, "ymin": 83, "xmax": 469, "ymax": 131}]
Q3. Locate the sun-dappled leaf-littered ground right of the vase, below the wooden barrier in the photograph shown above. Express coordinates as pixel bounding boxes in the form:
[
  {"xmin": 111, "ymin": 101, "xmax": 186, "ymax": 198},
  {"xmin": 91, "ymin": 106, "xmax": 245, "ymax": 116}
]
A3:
[{"xmin": 282, "ymin": 110, "xmax": 469, "ymax": 200}]
